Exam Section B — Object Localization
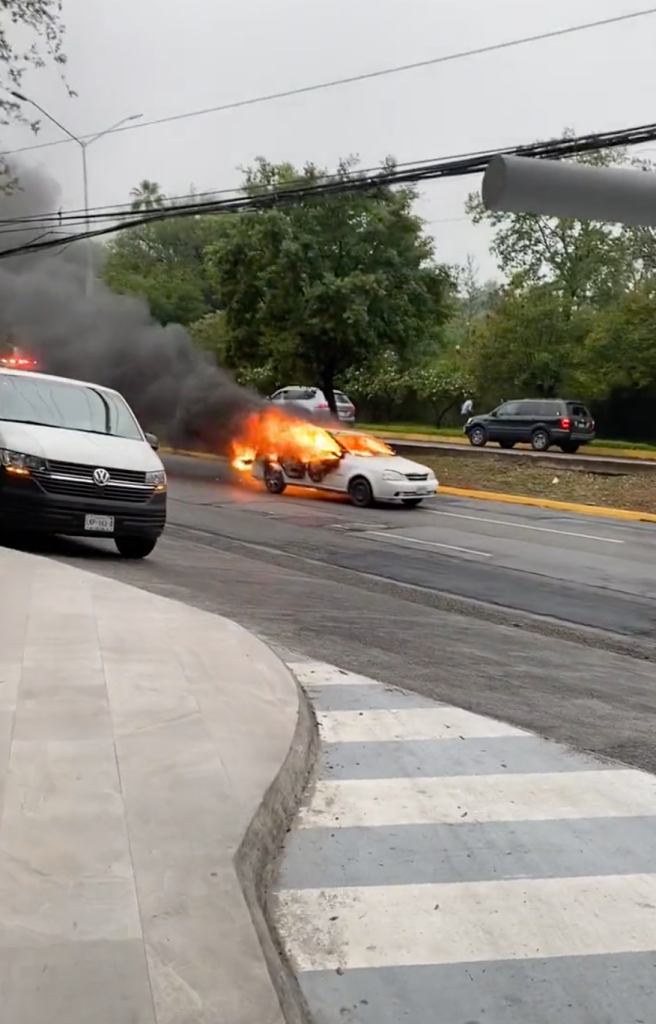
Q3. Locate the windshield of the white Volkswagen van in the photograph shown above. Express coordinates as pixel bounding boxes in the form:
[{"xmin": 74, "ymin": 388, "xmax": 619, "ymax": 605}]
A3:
[{"xmin": 0, "ymin": 374, "xmax": 143, "ymax": 440}]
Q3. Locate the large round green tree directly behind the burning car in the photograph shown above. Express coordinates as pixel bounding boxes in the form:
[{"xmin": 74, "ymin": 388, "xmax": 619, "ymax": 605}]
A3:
[{"xmin": 208, "ymin": 160, "xmax": 450, "ymax": 411}]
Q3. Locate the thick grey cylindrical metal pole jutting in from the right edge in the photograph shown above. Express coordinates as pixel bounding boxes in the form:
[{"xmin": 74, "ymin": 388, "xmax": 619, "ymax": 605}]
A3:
[{"xmin": 481, "ymin": 156, "xmax": 656, "ymax": 227}]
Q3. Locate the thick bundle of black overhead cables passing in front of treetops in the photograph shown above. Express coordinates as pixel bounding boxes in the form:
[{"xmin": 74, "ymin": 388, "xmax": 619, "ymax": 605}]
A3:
[{"xmin": 0, "ymin": 118, "xmax": 656, "ymax": 259}]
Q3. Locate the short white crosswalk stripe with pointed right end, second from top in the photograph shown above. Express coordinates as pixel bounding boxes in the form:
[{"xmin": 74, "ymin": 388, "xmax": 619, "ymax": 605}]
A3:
[{"xmin": 316, "ymin": 705, "xmax": 530, "ymax": 743}]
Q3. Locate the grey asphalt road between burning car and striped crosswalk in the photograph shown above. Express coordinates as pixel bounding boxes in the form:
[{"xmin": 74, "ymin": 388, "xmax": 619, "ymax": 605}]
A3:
[{"xmin": 7, "ymin": 458, "xmax": 656, "ymax": 770}]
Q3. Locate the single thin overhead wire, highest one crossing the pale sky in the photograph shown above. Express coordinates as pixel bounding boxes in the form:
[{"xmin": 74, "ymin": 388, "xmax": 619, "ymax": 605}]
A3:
[{"xmin": 0, "ymin": 7, "xmax": 656, "ymax": 157}]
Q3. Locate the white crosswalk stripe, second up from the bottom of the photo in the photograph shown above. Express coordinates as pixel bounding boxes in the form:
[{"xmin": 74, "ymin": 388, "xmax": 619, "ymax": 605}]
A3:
[{"xmin": 298, "ymin": 770, "xmax": 656, "ymax": 829}]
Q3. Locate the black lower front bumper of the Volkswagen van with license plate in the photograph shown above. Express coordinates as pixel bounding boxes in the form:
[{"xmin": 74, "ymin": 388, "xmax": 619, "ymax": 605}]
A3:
[{"xmin": 0, "ymin": 470, "xmax": 167, "ymax": 539}]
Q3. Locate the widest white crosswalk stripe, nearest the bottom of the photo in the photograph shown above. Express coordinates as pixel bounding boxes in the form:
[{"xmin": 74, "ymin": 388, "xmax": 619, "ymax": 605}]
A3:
[{"xmin": 277, "ymin": 874, "xmax": 656, "ymax": 971}]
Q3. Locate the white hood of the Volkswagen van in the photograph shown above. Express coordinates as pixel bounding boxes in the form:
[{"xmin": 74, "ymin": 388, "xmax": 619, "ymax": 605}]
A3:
[{"xmin": 0, "ymin": 420, "xmax": 163, "ymax": 472}]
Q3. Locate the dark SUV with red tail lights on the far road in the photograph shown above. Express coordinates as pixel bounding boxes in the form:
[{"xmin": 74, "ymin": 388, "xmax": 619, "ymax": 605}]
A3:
[{"xmin": 465, "ymin": 398, "xmax": 595, "ymax": 455}]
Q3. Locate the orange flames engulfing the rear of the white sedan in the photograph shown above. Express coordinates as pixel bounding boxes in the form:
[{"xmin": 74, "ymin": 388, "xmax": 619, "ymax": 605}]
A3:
[{"xmin": 229, "ymin": 409, "xmax": 342, "ymax": 472}]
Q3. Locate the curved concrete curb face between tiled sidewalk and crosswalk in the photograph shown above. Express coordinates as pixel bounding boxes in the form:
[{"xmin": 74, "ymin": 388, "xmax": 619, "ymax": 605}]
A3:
[{"xmin": 234, "ymin": 666, "xmax": 319, "ymax": 1024}]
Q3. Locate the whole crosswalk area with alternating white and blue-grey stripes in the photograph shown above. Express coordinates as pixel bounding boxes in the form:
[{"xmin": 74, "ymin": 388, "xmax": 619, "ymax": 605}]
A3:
[{"xmin": 272, "ymin": 664, "xmax": 656, "ymax": 1024}]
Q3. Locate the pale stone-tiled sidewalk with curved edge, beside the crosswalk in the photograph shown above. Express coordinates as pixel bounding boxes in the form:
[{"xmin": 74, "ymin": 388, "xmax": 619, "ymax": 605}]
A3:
[{"xmin": 0, "ymin": 548, "xmax": 312, "ymax": 1024}]
